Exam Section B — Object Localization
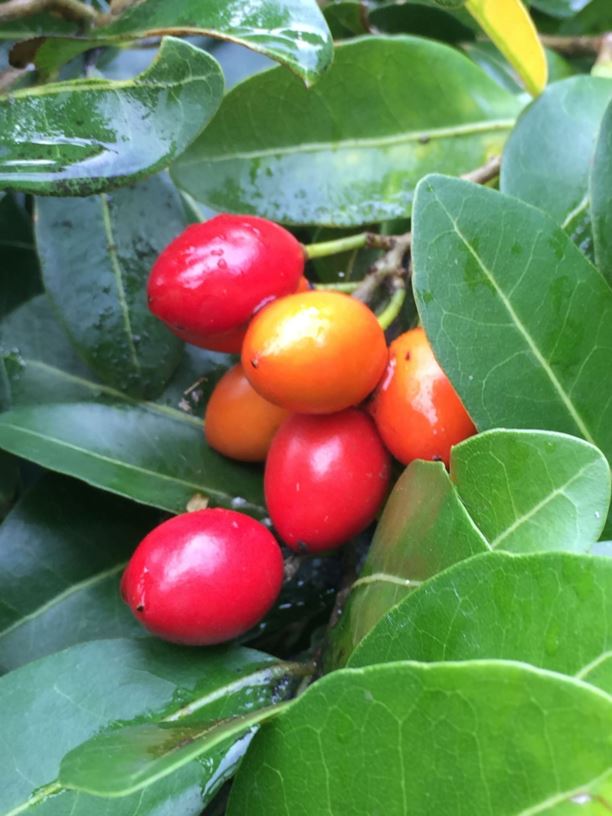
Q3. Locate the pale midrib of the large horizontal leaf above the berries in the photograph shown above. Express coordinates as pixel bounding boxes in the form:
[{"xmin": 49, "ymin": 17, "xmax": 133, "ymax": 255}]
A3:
[{"xmin": 179, "ymin": 118, "xmax": 516, "ymax": 167}]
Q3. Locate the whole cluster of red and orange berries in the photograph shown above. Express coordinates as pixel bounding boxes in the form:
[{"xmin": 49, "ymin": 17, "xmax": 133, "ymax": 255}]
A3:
[{"xmin": 122, "ymin": 215, "xmax": 475, "ymax": 644}]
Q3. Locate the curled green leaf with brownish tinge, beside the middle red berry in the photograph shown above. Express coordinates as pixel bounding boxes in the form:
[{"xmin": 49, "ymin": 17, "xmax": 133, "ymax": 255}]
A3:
[{"xmin": 326, "ymin": 461, "xmax": 488, "ymax": 669}]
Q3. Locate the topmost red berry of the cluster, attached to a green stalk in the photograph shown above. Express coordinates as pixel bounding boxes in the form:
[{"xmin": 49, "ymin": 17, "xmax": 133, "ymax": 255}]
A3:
[{"xmin": 147, "ymin": 215, "xmax": 305, "ymax": 351}]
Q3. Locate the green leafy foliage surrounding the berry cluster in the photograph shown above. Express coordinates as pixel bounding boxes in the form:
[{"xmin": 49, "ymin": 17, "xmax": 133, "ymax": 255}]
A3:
[{"xmin": 0, "ymin": 0, "xmax": 612, "ymax": 816}]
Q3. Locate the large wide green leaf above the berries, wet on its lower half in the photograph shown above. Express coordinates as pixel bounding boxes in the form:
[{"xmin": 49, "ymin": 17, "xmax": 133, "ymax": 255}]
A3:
[{"xmin": 172, "ymin": 36, "xmax": 520, "ymax": 226}]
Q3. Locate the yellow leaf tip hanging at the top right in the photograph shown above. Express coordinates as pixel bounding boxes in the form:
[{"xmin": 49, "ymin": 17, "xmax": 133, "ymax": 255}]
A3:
[{"xmin": 465, "ymin": 0, "xmax": 548, "ymax": 96}]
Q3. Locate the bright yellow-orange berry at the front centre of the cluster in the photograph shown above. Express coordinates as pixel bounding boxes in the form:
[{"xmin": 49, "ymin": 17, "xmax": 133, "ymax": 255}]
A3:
[{"xmin": 242, "ymin": 291, "xmax": 388, "ymax": 414}]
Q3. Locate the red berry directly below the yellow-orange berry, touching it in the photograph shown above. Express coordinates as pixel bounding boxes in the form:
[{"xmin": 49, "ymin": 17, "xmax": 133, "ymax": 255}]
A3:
[{"xmin": 264, "ymin": 408, "xmax": 390, "ymax": 553}]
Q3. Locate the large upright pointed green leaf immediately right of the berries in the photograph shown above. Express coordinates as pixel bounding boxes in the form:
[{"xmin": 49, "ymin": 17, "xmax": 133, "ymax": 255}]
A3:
[{"xmin": 413, "ymin": 176, "xmax": 612, "ymax": 536}]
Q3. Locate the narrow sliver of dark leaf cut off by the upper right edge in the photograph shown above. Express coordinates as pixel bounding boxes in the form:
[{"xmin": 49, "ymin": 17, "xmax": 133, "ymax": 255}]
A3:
[{"xmin": 589, "ymin": 98, "xmax": 612, "ymax": 284}]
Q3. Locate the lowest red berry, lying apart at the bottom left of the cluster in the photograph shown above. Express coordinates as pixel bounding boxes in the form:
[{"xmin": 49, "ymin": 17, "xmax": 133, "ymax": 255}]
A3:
[{"xmin": 121, "ymin": 509, "xmax": 283, "ymax": 646}]
